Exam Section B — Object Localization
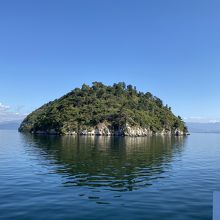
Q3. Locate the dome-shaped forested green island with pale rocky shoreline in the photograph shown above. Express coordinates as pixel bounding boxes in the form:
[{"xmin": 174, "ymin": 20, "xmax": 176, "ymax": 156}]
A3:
[{"xmin": 19, "ymin": 82, "xmax": 188, "ymax": 137}]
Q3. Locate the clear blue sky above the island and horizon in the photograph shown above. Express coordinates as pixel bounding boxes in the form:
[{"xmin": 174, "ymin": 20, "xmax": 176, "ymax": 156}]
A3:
[{"xmin": 0, "ymin": 0, "xmax": 220, "ymax": 121}]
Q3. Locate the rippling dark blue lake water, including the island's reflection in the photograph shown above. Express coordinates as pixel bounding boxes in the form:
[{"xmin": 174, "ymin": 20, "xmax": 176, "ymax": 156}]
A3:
[{"xmin": 0, "ymin": 131, "xmax": 220, "ymax": 220}]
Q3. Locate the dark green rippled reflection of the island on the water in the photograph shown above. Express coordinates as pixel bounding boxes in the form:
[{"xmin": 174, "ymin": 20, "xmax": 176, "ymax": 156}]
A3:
[{"xmin": 20, "ymin": 135, "xmax": 186, "ymax": 191}]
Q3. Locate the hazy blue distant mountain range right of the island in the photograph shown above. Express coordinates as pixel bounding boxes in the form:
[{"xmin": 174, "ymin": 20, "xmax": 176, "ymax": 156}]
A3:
[{"xmin": 186, "ymin": 122, "xmax": 220, "ymax": 133}]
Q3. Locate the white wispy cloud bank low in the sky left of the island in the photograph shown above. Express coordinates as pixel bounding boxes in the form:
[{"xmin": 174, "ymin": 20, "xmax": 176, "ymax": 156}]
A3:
[{"xmin": 0, "ymin": 102, "xmax": 27, "ymax": 122}]
